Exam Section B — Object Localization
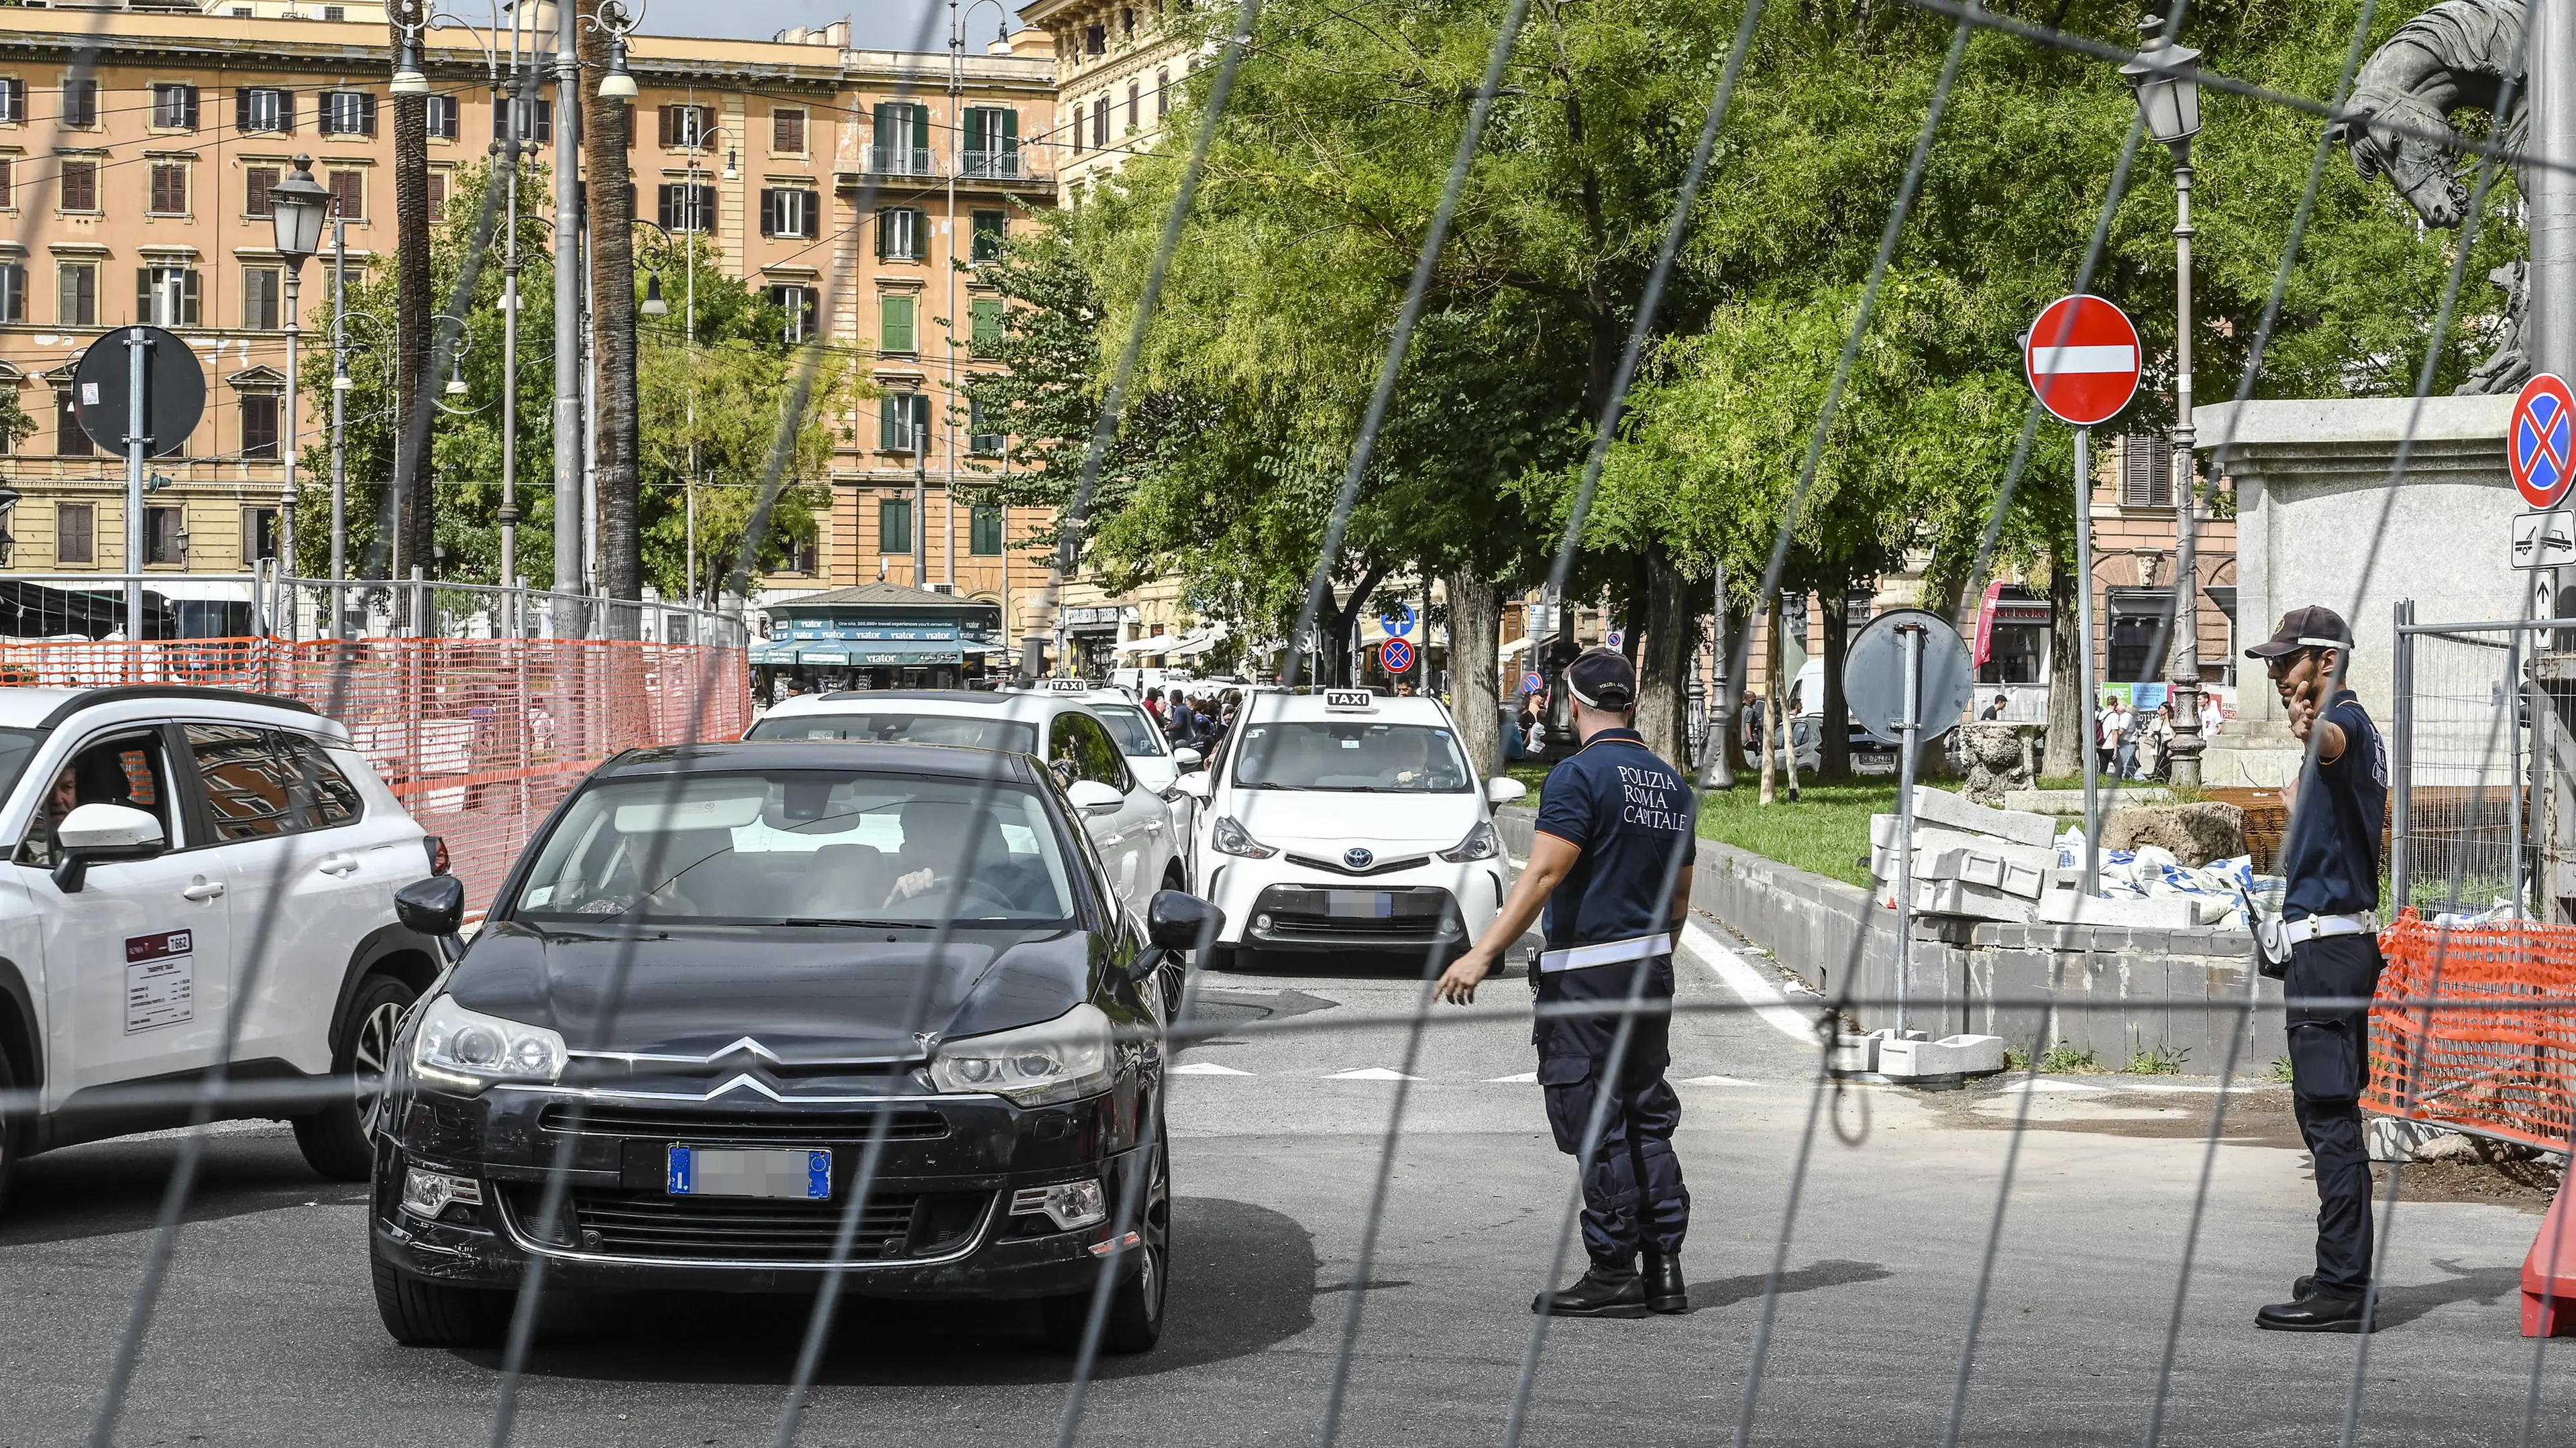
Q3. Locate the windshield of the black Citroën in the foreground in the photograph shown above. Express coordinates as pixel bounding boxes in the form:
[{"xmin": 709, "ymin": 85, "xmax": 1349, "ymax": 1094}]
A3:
[{"xmin": 507, "ymin": 771, "xmax": 1074, "ymax": 928}]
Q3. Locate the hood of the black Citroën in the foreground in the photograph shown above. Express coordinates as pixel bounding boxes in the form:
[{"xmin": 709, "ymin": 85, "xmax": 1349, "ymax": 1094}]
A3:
[{"xmin": 448, "ymin": 922, "xmax": 1097, "ymax": 1064}]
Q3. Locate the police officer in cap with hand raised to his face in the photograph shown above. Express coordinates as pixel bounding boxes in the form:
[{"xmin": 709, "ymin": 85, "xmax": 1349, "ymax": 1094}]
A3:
[{"xmin": 2246, "ymin": 608, "xmax": 2388, "ymax": 1332}]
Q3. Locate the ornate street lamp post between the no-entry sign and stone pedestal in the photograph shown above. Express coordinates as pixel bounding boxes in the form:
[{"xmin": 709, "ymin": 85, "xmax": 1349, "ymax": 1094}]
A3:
[{"xmin": 2123, "ymin": 15, "xmax": 2205, "ymax": 789}]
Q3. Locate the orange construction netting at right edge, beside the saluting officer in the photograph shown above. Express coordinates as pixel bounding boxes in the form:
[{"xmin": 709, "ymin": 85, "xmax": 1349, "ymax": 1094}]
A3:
[{"xmin": 2362, "ymin": 909, "xmax": 2576, "ymax": 1152}]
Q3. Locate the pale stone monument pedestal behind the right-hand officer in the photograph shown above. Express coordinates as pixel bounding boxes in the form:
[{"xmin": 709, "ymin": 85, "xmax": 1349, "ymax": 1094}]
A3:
[{"xmin": 2195, "ymin": 397, "xmax": 2524, "ymax": 789}]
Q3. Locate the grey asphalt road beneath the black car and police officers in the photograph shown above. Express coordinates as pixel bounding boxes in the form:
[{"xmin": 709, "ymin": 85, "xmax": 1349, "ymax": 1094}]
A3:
[{"xmin": 0, "ymin": 927, "xmax": 2576, "ymax": 1448}]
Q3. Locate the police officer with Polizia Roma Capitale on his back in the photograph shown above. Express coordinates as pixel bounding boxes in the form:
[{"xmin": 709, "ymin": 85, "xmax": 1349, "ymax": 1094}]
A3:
[{"xmin": 1440, "ymin": 649, "xmax": 1695, "ymax": 1317}]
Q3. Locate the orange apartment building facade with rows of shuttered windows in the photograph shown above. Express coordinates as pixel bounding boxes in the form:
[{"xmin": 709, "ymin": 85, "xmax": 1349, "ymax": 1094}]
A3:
[{"xmin": 0, "ymin": 3, "xmax": 1054, "ymax": 636}]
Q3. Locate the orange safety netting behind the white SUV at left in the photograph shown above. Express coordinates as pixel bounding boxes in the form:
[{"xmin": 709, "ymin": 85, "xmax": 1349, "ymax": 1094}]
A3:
[{"xmin": 0, "ymin": 628, "xmax": 752, "ymax": 912}]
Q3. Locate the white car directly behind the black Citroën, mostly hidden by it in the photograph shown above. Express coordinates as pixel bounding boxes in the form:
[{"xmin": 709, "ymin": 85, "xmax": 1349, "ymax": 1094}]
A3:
[{"xmin": 745, "ymin": 677, "xmax": 1198, "ymax": 920}]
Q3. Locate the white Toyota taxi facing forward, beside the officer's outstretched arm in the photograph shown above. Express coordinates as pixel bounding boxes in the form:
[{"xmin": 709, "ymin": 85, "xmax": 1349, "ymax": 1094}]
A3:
[{"xmin": 1177, "ymin": 688, "xmax": 1527, "ymax": 964}]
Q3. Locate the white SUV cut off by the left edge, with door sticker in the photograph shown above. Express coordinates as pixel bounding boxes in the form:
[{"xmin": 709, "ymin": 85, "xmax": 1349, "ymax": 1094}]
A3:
[{"xmin": 0, "ymin": 685, "xmax": 443, "ymax": 1196}]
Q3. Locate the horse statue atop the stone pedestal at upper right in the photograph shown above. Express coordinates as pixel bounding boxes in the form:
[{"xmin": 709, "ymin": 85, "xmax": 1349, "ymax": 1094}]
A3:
[{"xmin": 2334, "ymin": 0, "xmax": 2532, "ymax": 394}]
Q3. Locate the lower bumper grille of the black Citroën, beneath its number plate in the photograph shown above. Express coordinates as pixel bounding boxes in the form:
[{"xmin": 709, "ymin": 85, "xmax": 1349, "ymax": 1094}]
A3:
[{"xmin": 507, "ymin": 1182, "xmax": 991, "ymax": 1265}]
